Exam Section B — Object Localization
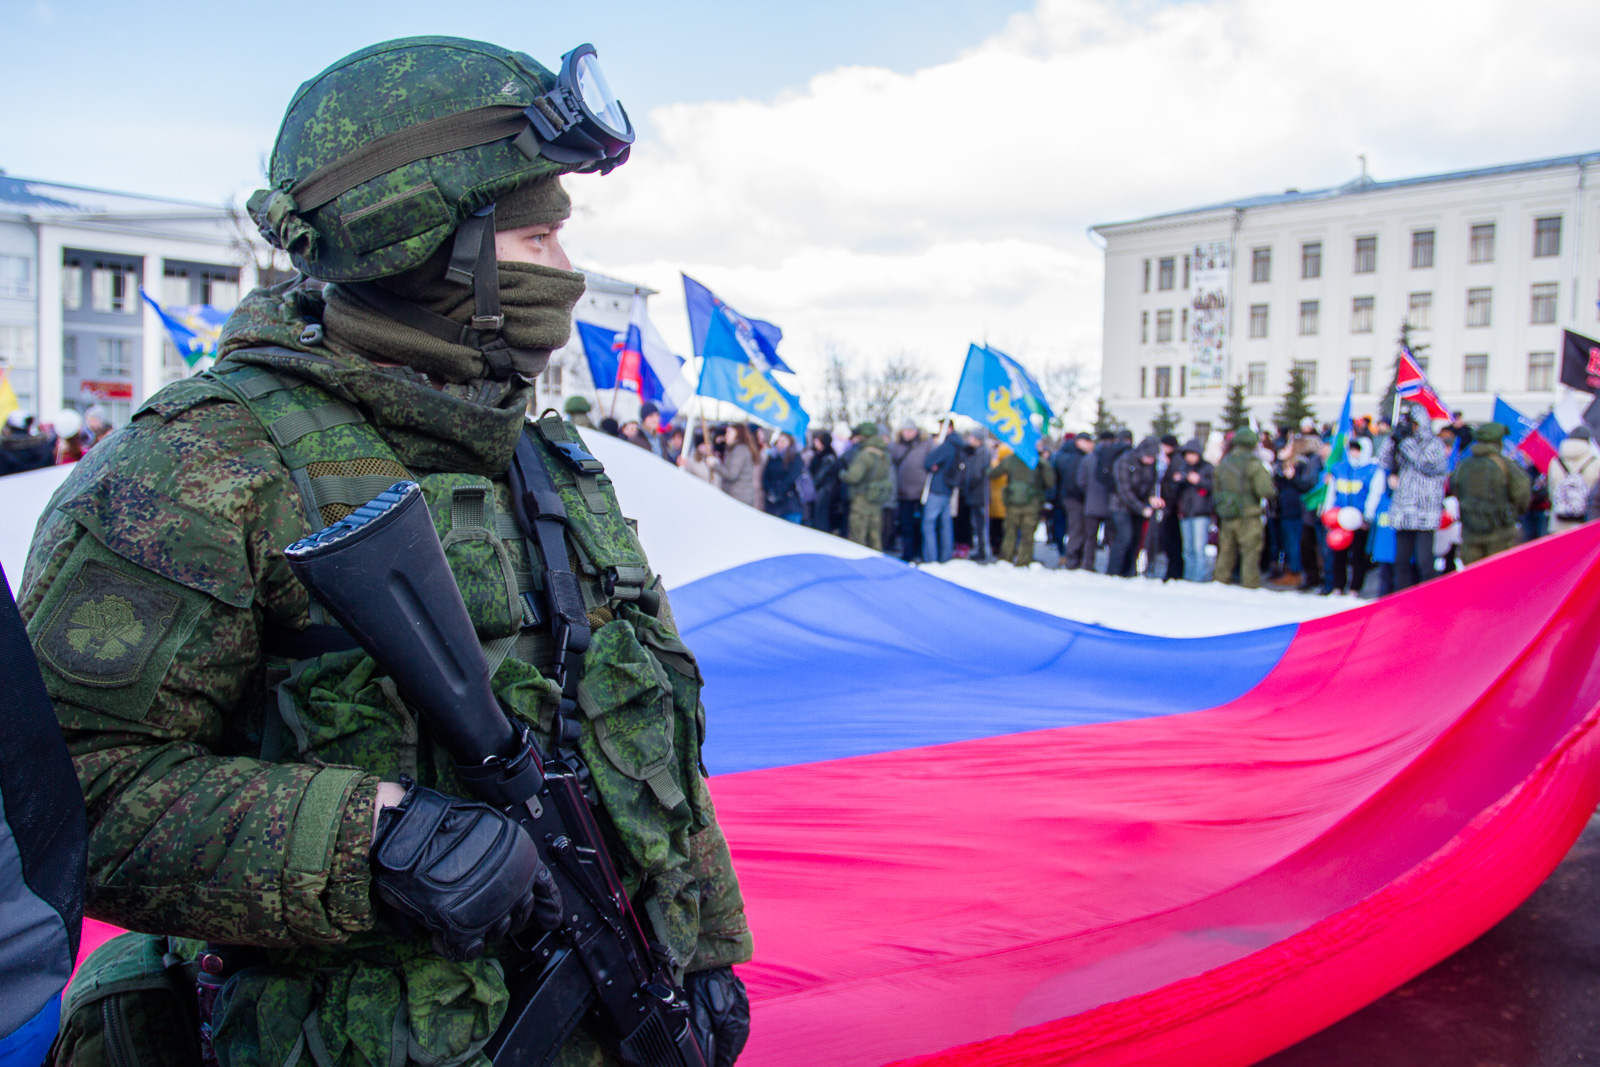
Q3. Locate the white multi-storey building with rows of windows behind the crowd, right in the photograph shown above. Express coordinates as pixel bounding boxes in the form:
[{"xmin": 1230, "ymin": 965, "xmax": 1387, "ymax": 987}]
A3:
[{"xmin": 1093, "ymin": 154, "xmax": 1600, "ymax": 434}]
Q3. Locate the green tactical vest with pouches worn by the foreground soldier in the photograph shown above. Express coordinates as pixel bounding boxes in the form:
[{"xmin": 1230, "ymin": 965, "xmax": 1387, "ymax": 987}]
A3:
[{"xmin": 137, "ymin": 352, "xmax": 712, "ymax": 1067}]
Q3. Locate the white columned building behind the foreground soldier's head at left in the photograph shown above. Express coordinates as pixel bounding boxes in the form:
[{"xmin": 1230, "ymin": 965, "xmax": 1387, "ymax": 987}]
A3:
[{"xmin": 0, "ymin": 171, "xmax": 654, "ymax": 426}]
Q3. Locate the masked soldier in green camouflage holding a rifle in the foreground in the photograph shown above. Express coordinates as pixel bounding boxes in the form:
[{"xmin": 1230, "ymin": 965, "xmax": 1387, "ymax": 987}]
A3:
[{"xmin": 21, "ymin": 38, "xmax": 750, "ymax": 1067}]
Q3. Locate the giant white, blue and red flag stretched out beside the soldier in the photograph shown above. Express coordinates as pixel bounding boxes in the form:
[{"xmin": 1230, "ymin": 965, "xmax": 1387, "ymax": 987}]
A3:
[{"xmin": 15, "ymin": 434, "xmax": 1600, "ymax": 1067}]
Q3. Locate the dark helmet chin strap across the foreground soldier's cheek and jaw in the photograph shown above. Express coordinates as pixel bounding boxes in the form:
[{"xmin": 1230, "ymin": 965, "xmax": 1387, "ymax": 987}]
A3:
[{"xmin": 341, "ymin": 203, "xmax": 549, "ymax": 381}]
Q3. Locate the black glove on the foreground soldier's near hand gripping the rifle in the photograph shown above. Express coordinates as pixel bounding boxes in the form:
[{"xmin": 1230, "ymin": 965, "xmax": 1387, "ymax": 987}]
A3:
[{"xmin": 373, "ymin": 784, "xmax": 562, "ymax": 960}]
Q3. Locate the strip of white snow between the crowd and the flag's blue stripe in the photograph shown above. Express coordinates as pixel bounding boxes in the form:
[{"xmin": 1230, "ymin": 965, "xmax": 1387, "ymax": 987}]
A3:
[{"xmin": 922, "ymin": 560, "xmax": 1365, "ymax": 637}]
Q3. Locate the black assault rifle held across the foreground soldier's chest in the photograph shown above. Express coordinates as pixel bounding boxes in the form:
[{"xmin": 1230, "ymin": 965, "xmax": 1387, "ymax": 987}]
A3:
[{"xmin": 283, "ymin": 482, "xmax": 706, "ymax": 1067}]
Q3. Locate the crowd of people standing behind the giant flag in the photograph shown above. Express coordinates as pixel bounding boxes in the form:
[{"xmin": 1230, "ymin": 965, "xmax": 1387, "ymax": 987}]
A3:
[{"xmin": 566, "ymin": 397, "xmax": 1600, "ymax": 597}]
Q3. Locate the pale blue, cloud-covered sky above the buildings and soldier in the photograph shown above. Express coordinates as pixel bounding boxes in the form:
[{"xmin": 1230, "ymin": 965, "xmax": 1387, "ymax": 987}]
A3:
[{"xmin": 0, "ymin": 0, "xmax": 1600, "ymax": 415}]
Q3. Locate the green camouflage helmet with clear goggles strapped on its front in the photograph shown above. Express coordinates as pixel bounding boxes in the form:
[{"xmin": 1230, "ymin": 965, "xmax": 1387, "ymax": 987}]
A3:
[{"xmin": 248, "ymin": 37, "xmax": 634, "ymax": 282}]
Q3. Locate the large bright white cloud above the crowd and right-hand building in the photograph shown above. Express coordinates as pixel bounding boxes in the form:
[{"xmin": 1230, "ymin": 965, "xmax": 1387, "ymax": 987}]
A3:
[{"xmin": 568, "ymin": 0, "xmax": 1600, "ymax": 425}]
